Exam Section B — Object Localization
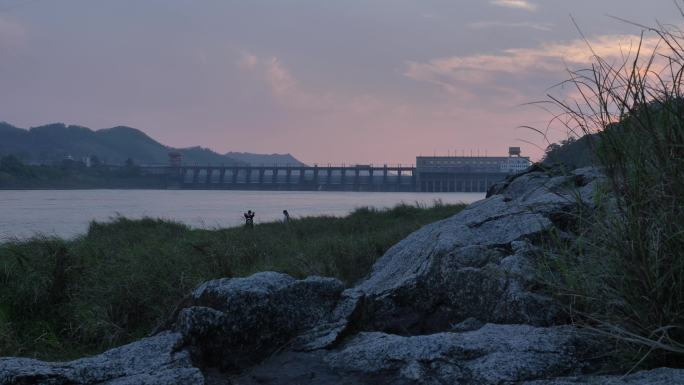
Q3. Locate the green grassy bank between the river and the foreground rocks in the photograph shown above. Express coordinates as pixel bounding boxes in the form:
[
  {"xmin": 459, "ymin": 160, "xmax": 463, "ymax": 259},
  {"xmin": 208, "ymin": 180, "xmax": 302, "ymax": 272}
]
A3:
[{"xmin": 0, "ymin": 203, "xmax": 464, "ymax": 360}]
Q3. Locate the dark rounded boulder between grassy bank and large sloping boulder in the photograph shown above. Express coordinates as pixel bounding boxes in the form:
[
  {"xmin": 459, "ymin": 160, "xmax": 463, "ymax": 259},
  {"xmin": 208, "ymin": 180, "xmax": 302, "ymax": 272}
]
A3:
[{"xmin": 172, "ymin": 272, "xmax": 345, "ymax": 372}]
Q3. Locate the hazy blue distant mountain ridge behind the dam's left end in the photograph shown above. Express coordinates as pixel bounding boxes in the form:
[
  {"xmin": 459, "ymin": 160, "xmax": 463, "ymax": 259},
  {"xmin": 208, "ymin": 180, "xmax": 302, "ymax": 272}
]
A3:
[{"xmin": 0, "ymin": 122, "xmax": 301, "ymax": 165}]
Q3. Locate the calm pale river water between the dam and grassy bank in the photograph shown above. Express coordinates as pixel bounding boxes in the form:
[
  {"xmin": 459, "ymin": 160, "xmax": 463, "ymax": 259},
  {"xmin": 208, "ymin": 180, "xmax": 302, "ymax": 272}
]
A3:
[{"xmin": 0, "ymin": 190, "xmax": 484, "ymax": 240}]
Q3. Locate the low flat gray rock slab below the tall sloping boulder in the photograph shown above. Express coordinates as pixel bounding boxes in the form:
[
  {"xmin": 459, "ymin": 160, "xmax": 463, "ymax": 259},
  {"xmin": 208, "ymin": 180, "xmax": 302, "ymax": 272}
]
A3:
[{"xmin": 326, "ymin": 324, "xmax": 582, "ymax": 384}]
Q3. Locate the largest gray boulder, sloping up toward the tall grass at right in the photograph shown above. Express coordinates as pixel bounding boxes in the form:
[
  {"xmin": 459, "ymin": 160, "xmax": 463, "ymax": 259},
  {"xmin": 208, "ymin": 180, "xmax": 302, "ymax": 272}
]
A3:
[{"xmin": 353, "ymin": 169, "xmax": 601, "ymax": 333}]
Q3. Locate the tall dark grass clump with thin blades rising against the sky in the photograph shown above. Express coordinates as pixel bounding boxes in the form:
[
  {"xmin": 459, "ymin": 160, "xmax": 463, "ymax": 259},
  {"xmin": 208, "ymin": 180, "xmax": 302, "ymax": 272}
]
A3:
[{"xmin": 547, "ymin": 16, "xmax": 684, "ymax": 367}]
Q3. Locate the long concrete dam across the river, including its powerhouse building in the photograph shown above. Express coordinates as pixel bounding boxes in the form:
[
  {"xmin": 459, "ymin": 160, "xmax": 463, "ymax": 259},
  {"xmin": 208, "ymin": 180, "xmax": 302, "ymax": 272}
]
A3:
[{"xmin": 142, "ymin": 147, "xmax": 530, "ymax": 192}]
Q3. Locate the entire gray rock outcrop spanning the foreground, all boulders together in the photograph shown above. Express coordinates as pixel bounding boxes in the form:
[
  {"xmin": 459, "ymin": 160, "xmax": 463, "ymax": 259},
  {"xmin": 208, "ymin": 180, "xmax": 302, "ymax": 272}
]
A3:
[{"xmin": 0, "ymin": 169, "xmax": 684, "ymax": 385}]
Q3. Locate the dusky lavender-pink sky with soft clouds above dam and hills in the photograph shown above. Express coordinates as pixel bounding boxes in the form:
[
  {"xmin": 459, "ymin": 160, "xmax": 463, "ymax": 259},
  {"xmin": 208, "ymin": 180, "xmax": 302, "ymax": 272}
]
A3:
[{"xmin": 0, "ymin": 0, "xmax": 682, "ymax": 164}]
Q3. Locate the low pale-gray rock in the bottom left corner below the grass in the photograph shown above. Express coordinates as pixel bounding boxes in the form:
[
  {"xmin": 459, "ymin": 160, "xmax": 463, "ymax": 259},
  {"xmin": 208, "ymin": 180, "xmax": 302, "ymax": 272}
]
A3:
[{"xmin": 0, "ymin": 332, "xmax": 205, "ymax": 385}]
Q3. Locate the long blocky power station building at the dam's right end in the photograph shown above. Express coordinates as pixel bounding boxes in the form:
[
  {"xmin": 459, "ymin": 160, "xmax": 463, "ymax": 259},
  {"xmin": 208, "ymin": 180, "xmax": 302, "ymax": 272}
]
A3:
[{"xmin": 415, "ymin": 147, "xmax": 531, "ymax": 192}]
